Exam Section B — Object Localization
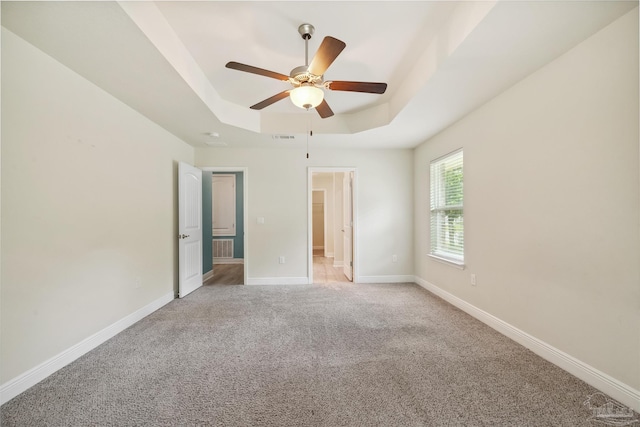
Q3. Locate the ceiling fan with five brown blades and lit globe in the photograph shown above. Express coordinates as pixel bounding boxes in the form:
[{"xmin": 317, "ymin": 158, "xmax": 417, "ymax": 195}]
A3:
[{"xmin": 226, "ymin": 24, "xmax": 387, "ymax": 119}]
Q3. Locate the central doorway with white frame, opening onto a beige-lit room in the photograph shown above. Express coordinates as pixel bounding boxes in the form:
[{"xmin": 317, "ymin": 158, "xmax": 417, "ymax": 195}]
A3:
[{"xmin": 308, "ymin": 167, "xmax": 357, "ymax": 284}]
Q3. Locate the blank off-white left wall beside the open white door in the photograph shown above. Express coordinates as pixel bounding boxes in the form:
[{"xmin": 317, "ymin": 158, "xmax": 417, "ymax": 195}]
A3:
[{"xmin": 0, "ymin": 29, "xmax": 193, "ymax": 386}]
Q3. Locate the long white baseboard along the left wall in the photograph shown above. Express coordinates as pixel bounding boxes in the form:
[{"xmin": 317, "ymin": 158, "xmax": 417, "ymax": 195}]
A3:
[{"xmin": 0, "ymin": 291, "xmax": 174, "ymax": 405}]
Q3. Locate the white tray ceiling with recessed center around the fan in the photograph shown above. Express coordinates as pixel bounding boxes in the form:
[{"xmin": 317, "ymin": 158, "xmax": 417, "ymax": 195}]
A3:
[{"xmin": 2, "ymin": 1, "xmax": 638, "ymax": 148}]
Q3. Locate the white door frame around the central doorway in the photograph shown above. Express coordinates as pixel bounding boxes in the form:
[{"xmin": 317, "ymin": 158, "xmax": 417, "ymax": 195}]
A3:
[{"xmin": 307, "ymin": 166, "xmax": 360, "ymax": 285}]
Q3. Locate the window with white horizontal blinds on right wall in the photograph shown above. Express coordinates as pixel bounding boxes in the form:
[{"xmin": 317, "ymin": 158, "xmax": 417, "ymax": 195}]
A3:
[{"xmin": 430, "ymin": 149, "xmax": 464, "ymax": 264}]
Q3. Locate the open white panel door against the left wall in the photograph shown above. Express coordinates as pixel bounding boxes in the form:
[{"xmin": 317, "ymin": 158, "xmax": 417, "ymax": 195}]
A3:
[{"xmin": 178, "ymin": 162, "xmax": 202, "ymax": 298}]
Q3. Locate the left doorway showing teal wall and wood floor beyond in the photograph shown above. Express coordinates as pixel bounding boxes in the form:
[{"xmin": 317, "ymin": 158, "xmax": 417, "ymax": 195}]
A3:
[{"xmin": 202, "ymin": 167, "xmax": 249, "ymax": 285}]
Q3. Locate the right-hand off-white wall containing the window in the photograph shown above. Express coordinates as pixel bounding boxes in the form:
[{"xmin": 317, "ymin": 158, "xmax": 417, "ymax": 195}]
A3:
[{"xmin": 414, "ymin": 8, "xmax": 640, "ymax": 394}]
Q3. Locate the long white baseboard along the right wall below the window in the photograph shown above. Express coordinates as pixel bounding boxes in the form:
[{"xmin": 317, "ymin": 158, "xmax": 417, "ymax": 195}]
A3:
[{"xmin": 415, "ymin": 277, "xmax": 640, "ymax": 411}]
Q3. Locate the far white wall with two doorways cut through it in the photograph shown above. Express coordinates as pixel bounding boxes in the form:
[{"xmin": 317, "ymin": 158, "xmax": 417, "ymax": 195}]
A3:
[{"xmin": 196, "ymin": 148, "xmax": 413, "ymax": 283}]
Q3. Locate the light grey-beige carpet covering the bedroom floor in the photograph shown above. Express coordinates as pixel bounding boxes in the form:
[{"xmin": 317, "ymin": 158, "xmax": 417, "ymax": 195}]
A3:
[{"xmin": 1, "ymin": 283, "xmax": 624, "ymax": 427}]
